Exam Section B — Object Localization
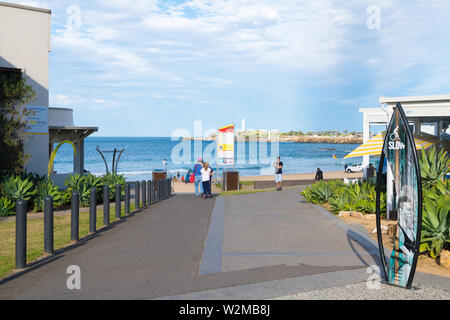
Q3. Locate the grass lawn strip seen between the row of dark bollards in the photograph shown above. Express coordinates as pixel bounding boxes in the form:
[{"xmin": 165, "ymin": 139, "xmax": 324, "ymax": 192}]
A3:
[{"xmin": 0, "ymin": 203, "xmax": 135, "ymax": 279}]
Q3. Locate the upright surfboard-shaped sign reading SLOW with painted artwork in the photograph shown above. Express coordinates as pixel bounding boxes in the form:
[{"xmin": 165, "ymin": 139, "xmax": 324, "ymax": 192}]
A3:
[{"xmin": 376, "ymin": 103, "xmax": 422, "ymax": 289}]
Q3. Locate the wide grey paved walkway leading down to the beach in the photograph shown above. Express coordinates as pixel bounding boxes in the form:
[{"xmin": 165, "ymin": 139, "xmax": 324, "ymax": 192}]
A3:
[{"xmin": 0, "ymin": 189, "xmax": 450, "ymax": 299}]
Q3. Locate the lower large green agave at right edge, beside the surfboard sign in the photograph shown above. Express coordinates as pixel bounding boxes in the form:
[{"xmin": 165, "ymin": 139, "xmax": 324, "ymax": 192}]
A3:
[{"xmin": 420, "ymin": 197, "xmax": 450, "ymax": 258}]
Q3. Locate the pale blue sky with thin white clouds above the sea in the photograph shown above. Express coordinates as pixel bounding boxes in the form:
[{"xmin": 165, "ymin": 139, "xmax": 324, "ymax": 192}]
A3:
[{"xmin": 8, "ymin": 0, "xmax": 450, "ymax": 137}]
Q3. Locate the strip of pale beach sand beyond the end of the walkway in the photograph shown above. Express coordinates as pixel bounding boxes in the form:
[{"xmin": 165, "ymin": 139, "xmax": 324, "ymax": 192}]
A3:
[{"xmin": 174, "ymin": 171, "xmax": 363, "ymax": 193}]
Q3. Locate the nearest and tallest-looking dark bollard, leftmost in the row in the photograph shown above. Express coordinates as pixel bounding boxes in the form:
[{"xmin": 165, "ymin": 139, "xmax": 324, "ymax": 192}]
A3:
[{"xmin": 16, "ymin": 199, "xmax": 27, "ymax": 269}]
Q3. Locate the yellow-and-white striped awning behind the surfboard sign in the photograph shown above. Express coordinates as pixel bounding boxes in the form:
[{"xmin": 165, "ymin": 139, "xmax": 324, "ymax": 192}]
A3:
[{"xmin": 344, "ymin": 131, "xmax": 439, "ymax": 159}]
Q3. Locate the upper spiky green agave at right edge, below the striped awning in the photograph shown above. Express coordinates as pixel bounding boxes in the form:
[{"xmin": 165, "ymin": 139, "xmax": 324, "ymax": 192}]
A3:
[{"xmin": 419, "ymin": 146, "xmax": 450, "ymax": 189}]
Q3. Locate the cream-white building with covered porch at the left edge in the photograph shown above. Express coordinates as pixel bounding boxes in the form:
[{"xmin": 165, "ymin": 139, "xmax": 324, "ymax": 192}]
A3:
[{"xmin": 0, "ymin": 2, "xmax": 98, "ymax": 186}]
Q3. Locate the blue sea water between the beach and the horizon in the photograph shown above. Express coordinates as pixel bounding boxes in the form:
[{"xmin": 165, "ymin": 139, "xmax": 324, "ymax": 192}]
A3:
[{"xmin": 55, "ymin": 137, "xmax": 361, "ymax": 180}]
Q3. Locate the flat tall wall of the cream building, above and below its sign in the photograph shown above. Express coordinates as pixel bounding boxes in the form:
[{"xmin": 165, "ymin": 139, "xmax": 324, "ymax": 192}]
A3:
[{"xmin": 0, "ymin": 2, "xmax": 51, "ymax": 175}]
